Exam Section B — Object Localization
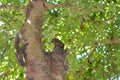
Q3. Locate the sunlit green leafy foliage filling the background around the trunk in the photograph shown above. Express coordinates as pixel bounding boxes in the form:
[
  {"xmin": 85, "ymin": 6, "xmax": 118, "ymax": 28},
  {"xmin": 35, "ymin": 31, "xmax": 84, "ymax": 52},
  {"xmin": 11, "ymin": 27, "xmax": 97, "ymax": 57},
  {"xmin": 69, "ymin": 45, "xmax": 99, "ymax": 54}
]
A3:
[{"xmin": 0, "ymin": 0, "xmax": 120, "ymax": 80}]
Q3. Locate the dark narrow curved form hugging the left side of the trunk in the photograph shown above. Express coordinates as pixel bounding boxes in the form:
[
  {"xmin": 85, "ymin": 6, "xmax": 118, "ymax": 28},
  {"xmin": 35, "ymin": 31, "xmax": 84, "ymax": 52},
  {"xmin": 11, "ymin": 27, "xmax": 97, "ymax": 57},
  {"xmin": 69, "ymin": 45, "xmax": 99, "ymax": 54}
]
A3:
[{"xmin": 14, "ymin": 32, "xmax": 27, "ymax": 67}]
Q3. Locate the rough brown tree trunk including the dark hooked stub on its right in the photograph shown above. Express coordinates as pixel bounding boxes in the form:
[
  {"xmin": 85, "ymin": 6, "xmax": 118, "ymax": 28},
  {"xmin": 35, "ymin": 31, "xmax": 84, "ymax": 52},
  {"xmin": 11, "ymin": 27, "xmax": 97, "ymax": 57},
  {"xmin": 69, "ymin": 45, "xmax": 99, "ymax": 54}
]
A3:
[{"xmin": 15, "ymin": 0, "xmax": 68, "ymax": 80}]
